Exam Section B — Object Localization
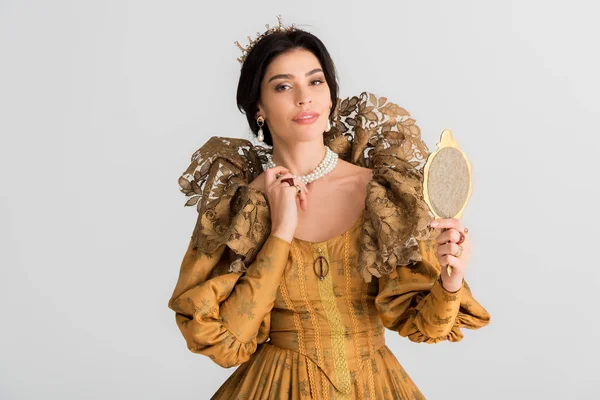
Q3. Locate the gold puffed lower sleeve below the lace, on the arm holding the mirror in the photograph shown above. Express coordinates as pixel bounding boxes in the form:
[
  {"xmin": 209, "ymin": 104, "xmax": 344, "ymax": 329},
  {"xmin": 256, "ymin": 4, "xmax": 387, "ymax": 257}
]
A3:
[{"xmin": 375, "ymin": 240, "xmax": 490, "ymax": 343}]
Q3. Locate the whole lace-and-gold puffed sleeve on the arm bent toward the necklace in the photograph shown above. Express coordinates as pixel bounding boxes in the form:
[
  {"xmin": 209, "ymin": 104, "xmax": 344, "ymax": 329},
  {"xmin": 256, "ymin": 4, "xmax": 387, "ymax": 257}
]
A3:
[{"xmin": 168, "ymin": 137, "xmax": 291, "ymax": 367}]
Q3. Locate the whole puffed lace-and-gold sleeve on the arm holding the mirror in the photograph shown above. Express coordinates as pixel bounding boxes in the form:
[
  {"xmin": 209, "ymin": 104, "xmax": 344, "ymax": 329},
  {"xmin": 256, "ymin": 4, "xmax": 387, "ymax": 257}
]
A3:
[{"xmin": 326, "ymin": 92, "xmax": 490, "ymax": 343}]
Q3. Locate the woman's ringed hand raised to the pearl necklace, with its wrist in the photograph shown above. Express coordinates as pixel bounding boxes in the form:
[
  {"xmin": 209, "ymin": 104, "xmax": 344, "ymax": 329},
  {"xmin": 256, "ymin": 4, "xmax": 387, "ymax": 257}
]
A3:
[{"xmin": 264, "ymin": 166, "xmax": 308, "ymax": 243}]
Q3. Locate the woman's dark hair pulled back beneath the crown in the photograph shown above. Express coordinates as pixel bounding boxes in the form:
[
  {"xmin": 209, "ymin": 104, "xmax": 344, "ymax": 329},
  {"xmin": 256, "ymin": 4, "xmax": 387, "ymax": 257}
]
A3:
[{"xmin": 237, "ymin": 28, "xmax": 338, "ymax": 146}]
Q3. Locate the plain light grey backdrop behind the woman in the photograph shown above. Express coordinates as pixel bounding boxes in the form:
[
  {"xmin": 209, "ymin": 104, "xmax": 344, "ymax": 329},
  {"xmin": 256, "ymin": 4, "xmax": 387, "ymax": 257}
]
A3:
[{"xmin": 0, "ymin": 0, "xmax": 600, "ymax": 400}]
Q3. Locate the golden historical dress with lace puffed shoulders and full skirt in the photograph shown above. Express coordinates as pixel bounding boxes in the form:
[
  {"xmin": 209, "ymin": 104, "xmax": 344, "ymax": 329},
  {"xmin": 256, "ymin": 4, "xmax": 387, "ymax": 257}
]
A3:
[{"xmin": 168, "ymin": 93, "xmax": 490, "ymax": 399}]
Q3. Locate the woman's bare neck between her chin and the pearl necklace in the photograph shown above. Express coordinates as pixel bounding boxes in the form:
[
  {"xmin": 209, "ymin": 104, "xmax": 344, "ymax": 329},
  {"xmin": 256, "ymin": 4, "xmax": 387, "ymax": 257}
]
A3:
[{"xmin": 272, "ymin": 139, "xmax": 326, "ymax": 176}]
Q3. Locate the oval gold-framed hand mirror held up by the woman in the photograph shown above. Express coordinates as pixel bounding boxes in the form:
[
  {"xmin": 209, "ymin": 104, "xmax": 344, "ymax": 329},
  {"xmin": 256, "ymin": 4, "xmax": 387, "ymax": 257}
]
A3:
[{"xmin": 423, "ymin": 129, "xmax": 472, "ymax": 275}]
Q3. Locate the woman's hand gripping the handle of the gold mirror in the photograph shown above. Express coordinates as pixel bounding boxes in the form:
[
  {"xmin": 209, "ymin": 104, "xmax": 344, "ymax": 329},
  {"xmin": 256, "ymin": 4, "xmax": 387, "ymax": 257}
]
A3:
[{"xmin": 431, "ymin": 218, "xmax": 471, "ymax": 292}]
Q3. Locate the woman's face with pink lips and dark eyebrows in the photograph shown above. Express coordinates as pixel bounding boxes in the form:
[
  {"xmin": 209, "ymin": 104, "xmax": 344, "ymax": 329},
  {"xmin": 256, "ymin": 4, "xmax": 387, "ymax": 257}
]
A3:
[{"xmin": 256, "ymin": 49, "xmax": 332, "ymax": 142}]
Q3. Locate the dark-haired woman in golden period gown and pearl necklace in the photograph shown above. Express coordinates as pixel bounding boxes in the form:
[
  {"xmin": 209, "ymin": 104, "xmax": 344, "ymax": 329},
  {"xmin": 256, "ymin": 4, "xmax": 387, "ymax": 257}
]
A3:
[{"xmin": 169, "ymin": 17, "xmax": 490, "ymax": 399}]
